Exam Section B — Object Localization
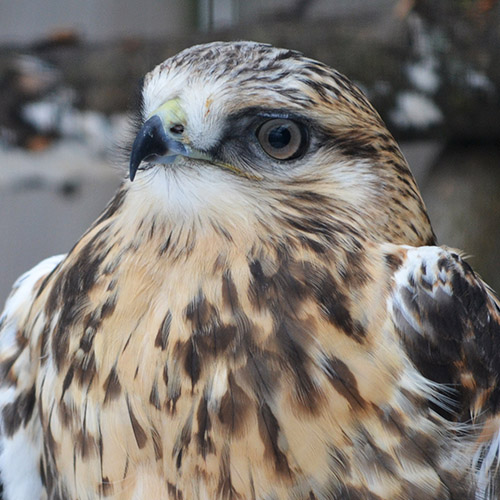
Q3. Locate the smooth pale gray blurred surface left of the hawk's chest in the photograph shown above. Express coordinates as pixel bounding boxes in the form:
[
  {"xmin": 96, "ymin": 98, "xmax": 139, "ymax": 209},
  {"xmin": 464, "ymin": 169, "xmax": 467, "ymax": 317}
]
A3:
[{"xmin": 0, "ymin": 141, "xmax": 124, "ymax": 304}]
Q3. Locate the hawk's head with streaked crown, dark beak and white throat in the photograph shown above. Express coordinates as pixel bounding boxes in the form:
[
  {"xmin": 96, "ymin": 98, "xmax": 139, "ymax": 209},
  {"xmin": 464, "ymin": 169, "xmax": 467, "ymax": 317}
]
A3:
[{"xmin": 128, "ymin": 42, "xmax": 433, "ymax": 245}]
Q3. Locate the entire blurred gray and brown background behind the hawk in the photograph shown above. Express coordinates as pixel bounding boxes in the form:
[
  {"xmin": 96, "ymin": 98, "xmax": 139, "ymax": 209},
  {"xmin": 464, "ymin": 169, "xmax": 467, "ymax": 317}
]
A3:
[{"xmin": 0, "ymin": 0, "xmax": 500, "ymax": 303}]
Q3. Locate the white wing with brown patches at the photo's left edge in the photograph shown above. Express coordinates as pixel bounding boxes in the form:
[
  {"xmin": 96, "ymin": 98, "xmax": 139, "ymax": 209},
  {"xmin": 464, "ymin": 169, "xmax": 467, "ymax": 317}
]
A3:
[{"xmin": 0, "ymin": 255, "xmax": 65, "ymax": 500}]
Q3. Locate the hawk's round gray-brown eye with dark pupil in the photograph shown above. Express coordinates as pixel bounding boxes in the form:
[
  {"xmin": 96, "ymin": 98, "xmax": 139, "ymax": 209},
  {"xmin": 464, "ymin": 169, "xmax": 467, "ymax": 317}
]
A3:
[{"xmin": 257, "ymin": 118, "xmax": 307, "ymax": 160}]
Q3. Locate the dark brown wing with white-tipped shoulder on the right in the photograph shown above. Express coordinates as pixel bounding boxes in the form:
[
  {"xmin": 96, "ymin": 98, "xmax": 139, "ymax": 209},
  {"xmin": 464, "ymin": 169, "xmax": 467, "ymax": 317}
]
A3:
[{"xmin": 390, "ymin": 247, "xmax": 500, "ymax": 499}]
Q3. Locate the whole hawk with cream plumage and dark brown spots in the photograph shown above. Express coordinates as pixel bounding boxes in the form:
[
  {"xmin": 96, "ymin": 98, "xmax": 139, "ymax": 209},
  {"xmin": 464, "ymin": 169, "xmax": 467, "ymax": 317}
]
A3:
[{"xmin": 0, "ymin": 42, "xmax": 500, "ymax": 500}]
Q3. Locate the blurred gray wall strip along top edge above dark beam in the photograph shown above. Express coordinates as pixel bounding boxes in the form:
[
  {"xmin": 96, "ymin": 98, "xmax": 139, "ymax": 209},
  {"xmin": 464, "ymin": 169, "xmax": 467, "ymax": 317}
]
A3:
[{"xmin": 0, "ymin": 0, "xmax": 397, "ymax": 44}]
